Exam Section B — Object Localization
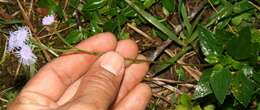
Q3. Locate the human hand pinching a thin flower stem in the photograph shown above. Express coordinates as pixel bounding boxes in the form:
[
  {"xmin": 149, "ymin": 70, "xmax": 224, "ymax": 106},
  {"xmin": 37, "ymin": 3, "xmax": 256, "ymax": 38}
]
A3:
[{"xmin": 8, "ymin": 33, "xmax": 151, "ymax": 110}]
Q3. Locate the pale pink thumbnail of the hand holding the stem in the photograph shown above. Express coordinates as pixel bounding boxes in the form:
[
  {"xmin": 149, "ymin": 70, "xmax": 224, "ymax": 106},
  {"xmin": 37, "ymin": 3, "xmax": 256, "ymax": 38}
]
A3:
[{"xmin": 100, "ymin": 52, "xmax": 124, "ymax": 75}]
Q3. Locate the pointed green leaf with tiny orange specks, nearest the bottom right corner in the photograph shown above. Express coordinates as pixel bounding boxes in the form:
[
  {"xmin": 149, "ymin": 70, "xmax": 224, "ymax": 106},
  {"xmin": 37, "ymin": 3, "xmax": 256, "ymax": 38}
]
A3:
[{"xmin": 231, "ymin": 71, "xmax": 255, "ymax": 107}]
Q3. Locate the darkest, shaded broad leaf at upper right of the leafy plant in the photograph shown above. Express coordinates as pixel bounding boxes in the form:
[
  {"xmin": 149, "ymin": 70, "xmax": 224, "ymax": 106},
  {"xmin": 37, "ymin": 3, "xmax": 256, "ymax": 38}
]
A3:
[{"xmin": 227, "ymin": 27, "xmax": 256, "ymax": 60}]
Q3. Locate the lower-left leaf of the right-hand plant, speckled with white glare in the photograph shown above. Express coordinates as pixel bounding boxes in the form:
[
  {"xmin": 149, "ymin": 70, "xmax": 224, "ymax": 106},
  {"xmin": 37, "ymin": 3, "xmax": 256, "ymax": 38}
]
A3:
[{"xmin": 193, "ymin": 69, "xmax": 213, "ymax": 99}]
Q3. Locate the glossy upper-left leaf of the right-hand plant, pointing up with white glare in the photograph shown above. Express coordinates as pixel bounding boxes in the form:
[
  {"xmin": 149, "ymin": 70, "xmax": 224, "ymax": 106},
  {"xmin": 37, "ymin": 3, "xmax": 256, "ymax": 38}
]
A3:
[{"xmin": 198, "ymin": 26, "xmax": 224, "ymax": 56}]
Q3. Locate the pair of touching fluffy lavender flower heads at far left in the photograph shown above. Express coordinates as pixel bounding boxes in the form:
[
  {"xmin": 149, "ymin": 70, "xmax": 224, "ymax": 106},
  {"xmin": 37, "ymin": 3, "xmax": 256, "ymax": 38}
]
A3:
[{"xmin": 7, "ymin": 26, "xmax": 37, "ymax": 65}]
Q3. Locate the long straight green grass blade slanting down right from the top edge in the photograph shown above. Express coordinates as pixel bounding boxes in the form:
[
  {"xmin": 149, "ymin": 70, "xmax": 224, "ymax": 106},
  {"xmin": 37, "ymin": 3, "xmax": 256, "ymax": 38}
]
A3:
[{"xmin": 125, "ymin": 0, "xmax": 185, "ymax": 46}]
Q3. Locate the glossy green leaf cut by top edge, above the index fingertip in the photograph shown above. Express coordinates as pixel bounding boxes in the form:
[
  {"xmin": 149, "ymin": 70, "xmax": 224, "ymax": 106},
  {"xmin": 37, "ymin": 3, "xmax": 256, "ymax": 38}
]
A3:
[{"xmin": 83, "ymin": 0, "xmax": 108, "ymax": 11}]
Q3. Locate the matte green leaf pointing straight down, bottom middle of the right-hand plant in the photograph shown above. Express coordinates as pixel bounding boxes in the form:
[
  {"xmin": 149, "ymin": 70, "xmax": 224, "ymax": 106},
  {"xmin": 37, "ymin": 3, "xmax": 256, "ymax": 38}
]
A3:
[{"xmin": 210, "ymin": 68, "xmax": 231, "ymax": 104}]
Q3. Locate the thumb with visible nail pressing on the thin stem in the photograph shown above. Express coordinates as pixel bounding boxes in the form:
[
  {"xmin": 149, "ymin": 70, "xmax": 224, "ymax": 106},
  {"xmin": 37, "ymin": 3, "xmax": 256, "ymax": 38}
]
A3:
[{"xmin": 62, "ymin": 52, "xmax": 125, "ymax": 110}]
